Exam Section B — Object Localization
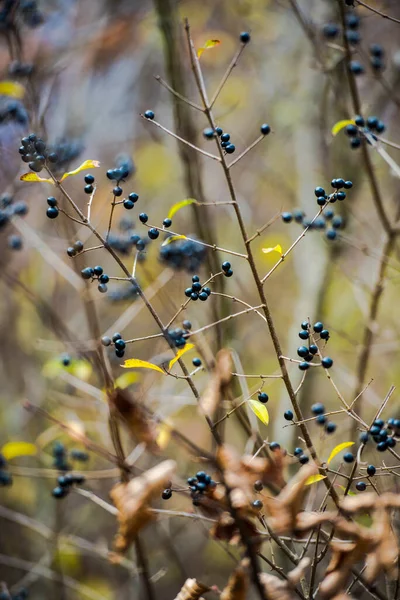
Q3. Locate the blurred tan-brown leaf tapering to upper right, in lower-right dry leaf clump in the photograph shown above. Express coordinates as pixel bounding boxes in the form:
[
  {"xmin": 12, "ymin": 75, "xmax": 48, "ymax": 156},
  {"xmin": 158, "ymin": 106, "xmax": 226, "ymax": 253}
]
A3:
[{"xmin": 263, "ymin": 464, "xmax": 317, "ymax": 535}]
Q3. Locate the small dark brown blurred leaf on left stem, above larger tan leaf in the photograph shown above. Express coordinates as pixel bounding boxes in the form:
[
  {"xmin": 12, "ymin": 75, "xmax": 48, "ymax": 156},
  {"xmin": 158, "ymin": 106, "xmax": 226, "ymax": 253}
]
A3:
[{"xmin": 109, "ymin": 388, "xmax": 158, "ymax": 451}]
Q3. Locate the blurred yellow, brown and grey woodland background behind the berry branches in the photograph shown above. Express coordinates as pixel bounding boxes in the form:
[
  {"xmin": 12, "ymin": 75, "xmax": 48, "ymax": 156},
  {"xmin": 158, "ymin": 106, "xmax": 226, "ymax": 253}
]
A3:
[{"xmin": 0, "ymin": 0, "xmax": 400, "ymax": 600}]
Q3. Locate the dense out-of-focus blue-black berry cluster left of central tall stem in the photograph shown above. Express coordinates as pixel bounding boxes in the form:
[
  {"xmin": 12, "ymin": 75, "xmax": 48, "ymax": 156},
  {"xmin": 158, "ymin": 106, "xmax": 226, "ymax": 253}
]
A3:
[{"xmin": 159, "ymin": 234, "xmax": 207, "ymax": 273}]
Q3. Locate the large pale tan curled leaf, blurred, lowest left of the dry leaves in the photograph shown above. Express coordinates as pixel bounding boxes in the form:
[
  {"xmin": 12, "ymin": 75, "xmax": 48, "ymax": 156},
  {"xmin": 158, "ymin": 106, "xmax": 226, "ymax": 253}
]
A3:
[{"xmin": 110, "ymin": 460, "xmax": 176, "ymax": 552}]
